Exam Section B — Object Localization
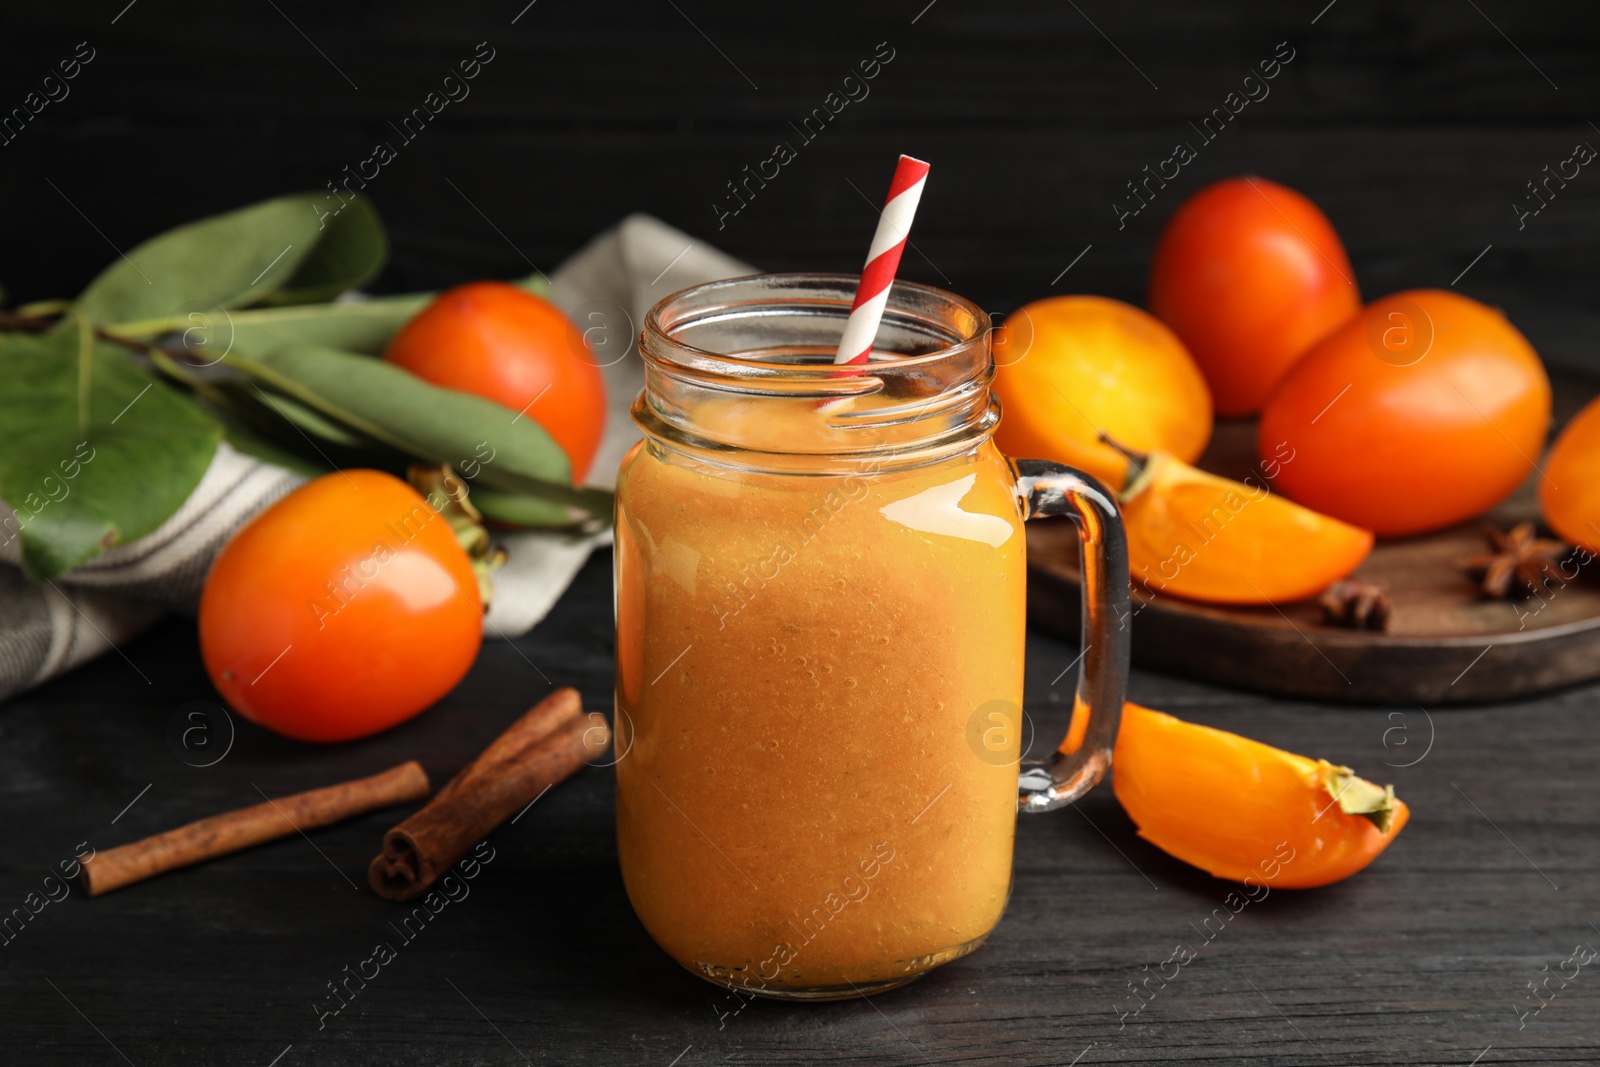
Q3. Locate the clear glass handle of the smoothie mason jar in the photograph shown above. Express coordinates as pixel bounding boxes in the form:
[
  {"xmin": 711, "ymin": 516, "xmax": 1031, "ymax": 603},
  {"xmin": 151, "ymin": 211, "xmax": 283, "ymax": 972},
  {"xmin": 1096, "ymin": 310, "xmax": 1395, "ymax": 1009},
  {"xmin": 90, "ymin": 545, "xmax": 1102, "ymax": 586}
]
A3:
[{"xmin": 1013, "ymin": 459, "xmax": 1130, "ymax": 813}]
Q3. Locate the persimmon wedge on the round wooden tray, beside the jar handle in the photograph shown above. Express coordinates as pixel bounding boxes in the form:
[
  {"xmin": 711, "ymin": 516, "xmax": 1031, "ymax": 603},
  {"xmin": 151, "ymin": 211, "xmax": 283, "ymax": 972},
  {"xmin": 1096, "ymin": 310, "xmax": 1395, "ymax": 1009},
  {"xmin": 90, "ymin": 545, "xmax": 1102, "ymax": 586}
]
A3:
[{"xmin": 1122, "ymin": 453, "xmax": 1373, "ymax": 605}]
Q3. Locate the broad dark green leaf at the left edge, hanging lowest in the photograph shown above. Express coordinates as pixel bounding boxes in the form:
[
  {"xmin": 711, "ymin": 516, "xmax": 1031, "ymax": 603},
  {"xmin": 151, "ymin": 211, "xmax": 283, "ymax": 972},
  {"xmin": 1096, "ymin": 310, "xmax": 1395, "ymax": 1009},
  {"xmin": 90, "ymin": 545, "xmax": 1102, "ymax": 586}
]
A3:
[{"xmin": 0, "ymin": 329, "xmax": 221, "ymax": 581}]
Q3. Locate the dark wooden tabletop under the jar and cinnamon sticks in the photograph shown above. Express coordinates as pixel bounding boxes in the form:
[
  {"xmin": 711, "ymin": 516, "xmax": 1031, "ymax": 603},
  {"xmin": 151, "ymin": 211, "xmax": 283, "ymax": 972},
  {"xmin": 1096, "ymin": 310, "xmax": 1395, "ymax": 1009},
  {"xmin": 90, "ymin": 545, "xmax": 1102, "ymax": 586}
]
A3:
[{"xmin": 0, "ymin": 553, "xmax": 1600, "ymax": 1067}]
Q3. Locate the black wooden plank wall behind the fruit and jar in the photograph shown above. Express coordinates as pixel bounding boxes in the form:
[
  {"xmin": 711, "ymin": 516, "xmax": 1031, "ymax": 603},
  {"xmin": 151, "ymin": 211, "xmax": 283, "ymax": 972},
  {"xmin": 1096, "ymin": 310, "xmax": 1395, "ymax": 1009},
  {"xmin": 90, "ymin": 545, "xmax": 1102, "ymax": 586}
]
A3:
[{"xmin": 9, "ymin": 0, "xmax": 1600, "ymax": 362}]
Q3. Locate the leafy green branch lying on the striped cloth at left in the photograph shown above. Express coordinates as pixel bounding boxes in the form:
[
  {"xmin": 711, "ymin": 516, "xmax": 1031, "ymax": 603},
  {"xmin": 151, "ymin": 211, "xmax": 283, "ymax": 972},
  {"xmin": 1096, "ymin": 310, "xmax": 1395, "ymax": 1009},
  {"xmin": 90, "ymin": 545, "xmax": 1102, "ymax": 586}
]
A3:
[{"xmin": 0, "ymin": 194, "xmax": 611, "ymax": 579}]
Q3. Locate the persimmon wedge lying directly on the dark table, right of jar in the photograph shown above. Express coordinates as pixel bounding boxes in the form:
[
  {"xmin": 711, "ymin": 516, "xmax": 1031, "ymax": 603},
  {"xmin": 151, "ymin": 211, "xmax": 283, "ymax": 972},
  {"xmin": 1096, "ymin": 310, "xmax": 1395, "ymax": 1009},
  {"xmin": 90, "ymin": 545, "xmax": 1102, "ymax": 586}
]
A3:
[{"xmin": 1112, "ymin": 704, "xmax": 1411, "ymax": 889}]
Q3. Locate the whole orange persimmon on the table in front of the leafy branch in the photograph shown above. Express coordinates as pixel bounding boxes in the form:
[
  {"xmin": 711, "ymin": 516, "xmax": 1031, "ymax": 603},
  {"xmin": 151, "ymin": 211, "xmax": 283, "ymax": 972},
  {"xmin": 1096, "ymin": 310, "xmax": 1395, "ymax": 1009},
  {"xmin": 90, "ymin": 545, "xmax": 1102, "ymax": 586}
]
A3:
[{"xmin": 200, "ymin": 470, "xmax": 483, "ymax": 741}]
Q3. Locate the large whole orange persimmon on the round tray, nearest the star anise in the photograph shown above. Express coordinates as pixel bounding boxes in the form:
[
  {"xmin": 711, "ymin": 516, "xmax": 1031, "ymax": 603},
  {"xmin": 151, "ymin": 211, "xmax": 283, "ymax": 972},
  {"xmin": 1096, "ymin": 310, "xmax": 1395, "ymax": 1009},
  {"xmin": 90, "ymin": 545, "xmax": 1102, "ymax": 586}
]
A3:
[{"xmin": 1256, "ymin": 290, "xmax": 1550, "ymax": 537}]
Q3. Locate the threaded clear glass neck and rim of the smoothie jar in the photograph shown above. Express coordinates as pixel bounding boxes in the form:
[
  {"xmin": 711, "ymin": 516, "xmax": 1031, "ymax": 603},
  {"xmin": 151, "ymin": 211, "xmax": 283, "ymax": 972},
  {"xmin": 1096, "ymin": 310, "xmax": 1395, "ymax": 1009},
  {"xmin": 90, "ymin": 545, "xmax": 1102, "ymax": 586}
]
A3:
[{"xmin": 632, "ymin": 272, "xmax": 1000, "ymax": 474}]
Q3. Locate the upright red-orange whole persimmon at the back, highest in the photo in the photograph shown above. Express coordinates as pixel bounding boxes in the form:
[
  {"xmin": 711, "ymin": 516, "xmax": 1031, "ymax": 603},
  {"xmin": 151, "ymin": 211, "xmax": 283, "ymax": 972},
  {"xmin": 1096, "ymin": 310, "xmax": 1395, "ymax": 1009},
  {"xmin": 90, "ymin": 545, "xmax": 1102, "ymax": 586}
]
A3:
[{"xmin": 1150, "ymin": 178, "xmax": 1362, "ymax": 416}]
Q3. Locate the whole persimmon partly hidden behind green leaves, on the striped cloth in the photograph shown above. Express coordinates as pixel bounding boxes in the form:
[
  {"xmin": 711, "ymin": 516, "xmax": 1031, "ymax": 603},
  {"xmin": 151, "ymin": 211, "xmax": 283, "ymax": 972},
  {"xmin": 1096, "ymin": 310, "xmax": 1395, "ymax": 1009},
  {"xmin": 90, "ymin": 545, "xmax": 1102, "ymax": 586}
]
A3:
[{"xmin": 384, "ymin": 282, "xmax": 606, "ymax": 485}]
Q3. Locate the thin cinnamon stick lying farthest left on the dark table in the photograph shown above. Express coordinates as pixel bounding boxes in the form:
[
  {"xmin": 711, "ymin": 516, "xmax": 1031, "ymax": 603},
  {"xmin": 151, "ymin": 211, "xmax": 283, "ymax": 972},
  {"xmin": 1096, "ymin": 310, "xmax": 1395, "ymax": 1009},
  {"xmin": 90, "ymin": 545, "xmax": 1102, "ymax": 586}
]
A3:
[{"xmin": 80, "ymin": 760, "xmax": 429, "ymax": 896}]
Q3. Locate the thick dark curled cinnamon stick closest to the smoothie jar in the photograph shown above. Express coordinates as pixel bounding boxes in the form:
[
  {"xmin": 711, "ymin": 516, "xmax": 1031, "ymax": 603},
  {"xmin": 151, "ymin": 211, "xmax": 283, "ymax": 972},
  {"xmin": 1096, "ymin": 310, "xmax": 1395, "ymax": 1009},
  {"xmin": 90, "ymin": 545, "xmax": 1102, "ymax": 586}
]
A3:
[{"xmin": 366, "ymin": 688, "xmax": 611, "ymax": 901}]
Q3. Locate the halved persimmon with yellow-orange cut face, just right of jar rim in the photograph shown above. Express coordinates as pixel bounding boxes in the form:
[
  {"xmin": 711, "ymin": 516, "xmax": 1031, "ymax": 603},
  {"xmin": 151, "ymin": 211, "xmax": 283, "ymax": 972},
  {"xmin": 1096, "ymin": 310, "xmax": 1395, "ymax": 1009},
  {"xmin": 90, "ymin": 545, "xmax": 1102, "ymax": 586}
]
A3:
[{"xmin": 994, "ymin": 296, "xmax": 1211, "ymax": 490}]
